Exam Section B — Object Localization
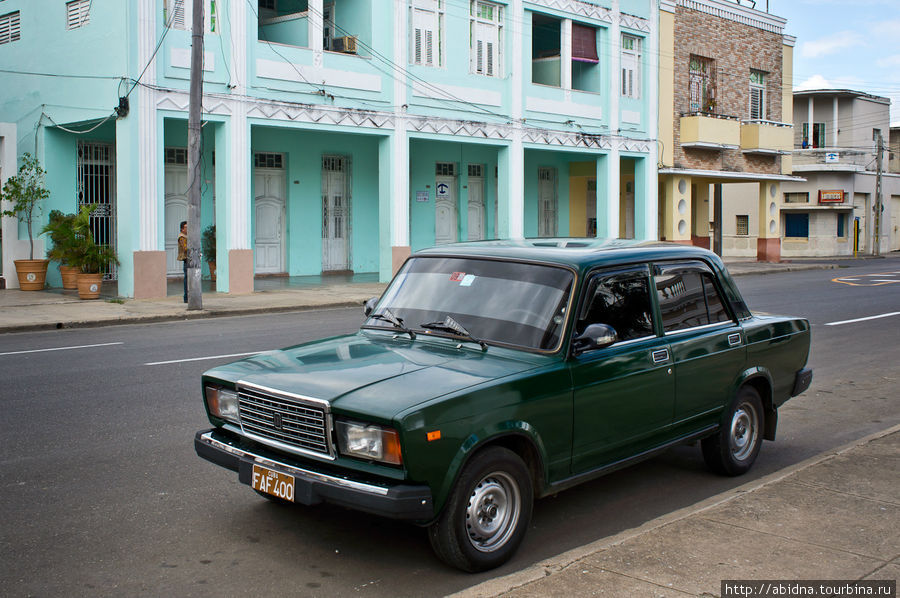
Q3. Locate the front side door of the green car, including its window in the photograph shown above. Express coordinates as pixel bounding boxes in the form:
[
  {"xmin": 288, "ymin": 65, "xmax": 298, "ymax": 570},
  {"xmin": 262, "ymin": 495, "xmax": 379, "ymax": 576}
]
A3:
[{"xmin": 570, "ymin": 265, "xmax": 675, "ymax": 474}]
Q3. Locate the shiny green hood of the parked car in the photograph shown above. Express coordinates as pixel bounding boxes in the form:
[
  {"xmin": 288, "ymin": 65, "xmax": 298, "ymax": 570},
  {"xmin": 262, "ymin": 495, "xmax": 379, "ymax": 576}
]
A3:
[{"xmin": 204, "ymin": 332, "xmax": 548, "ymax": 420}]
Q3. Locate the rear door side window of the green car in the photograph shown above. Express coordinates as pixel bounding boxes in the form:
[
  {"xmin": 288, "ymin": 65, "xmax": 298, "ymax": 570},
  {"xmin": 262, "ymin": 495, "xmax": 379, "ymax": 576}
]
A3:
[{"xmin": 654, "ymin": 270, "xmax": 731, "ymax": 332}]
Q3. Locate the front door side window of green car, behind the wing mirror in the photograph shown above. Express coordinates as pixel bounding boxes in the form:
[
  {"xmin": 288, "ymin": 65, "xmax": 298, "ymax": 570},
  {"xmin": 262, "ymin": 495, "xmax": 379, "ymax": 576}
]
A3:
[{"xmin": 576, "ymin": 271, "xmax": 655, "ymax": 340}]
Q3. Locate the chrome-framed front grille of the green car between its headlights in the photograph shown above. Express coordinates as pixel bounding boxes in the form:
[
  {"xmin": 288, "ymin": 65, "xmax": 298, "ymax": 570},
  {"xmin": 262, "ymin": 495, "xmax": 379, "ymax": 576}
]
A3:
[{"xmin": 238, "ymin": 385, "xmax": 332, "ymax": 457}]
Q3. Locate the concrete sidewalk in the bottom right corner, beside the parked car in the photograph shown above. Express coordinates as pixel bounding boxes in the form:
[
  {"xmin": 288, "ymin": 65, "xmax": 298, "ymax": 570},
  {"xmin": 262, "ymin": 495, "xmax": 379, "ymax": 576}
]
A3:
[{"xmin": 453, "ymin": 426, "xmax": 900, "ymax": 598}]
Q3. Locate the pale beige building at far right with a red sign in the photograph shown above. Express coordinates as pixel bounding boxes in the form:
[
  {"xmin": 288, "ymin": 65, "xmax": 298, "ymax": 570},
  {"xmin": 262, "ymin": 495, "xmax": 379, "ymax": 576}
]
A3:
[{"xmin": 723, "ymin": 89, "xmax": 900, "ymax": 258}]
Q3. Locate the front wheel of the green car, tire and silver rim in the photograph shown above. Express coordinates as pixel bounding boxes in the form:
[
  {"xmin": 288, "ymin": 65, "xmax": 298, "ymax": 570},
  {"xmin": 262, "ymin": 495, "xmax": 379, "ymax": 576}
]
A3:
[{"xmin": 428, "ymin": 446, "xmax": 533, "ymax": 573}]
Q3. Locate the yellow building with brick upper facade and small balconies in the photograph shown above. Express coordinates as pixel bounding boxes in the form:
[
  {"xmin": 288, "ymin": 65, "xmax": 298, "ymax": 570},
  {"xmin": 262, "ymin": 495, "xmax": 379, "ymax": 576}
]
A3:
[{"xmin": 659, "ymin": 0, "xmax": 795, "ymax": 261}]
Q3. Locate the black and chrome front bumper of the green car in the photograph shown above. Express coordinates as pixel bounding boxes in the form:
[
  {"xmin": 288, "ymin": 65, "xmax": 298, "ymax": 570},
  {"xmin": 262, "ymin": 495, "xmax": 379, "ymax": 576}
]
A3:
[{"xmin": 194, "ymin": 429, "xmax": 434, "ymax": 521}]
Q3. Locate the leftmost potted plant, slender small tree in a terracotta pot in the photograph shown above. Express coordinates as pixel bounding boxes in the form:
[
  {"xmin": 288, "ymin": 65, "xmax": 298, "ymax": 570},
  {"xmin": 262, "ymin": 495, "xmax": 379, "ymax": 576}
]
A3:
[{"xmin": 0, "ymin": 153, "xmax": 50, "ymax": 291}]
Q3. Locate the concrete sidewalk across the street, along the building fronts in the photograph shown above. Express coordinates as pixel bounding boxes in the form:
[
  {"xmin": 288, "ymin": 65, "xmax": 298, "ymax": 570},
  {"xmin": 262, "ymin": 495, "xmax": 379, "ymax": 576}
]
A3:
[{"xmin": 0, "ymin": 261, "xmax": 837, "ymax": 333}]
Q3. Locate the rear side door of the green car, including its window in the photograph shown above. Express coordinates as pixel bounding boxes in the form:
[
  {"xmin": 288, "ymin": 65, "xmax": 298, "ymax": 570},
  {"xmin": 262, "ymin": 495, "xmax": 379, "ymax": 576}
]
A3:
[{"xmin": 653, "ymin": 261, "xmax": 747, "ymax": 428}]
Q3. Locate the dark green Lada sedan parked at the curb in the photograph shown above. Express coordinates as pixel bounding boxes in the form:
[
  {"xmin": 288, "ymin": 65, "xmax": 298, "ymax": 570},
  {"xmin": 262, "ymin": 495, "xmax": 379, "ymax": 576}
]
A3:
[{"xmin": 194, "ymin": 239, "xmax": 812, "ymax": 571}]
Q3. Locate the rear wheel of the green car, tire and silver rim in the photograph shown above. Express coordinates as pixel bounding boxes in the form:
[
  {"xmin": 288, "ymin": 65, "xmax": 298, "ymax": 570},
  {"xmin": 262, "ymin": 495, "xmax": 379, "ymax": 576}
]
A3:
[{"xmin": 700, "ymin": 386, "xmax": 764, "ymax": 476}]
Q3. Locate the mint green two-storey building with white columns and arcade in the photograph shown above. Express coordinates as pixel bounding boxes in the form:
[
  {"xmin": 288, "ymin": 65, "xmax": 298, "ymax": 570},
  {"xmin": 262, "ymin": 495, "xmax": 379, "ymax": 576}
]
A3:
[{"xmin": 0, "ymin": 0, "xmax": 659, "ymax": 297}]
